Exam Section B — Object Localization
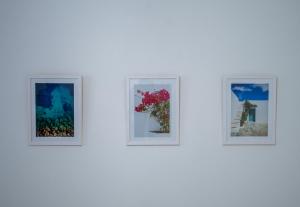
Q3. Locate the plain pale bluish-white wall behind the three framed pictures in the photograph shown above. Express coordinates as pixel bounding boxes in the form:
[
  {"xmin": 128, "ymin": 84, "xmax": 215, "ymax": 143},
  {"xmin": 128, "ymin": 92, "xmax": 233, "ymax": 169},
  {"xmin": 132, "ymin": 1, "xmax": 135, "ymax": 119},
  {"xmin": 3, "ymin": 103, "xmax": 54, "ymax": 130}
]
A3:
[{"xmin": 0, "ymin": 0, "xmax": 300, "ymax": 207}]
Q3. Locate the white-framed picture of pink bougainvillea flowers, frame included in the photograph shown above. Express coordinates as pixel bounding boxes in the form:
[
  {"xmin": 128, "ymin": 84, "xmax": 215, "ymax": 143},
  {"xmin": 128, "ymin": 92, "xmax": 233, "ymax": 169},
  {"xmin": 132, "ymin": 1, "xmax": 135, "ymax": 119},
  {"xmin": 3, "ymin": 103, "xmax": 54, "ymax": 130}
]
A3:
[{"xmin": 127, "ymin": 75, "xmax": 179, "ymax": 145}]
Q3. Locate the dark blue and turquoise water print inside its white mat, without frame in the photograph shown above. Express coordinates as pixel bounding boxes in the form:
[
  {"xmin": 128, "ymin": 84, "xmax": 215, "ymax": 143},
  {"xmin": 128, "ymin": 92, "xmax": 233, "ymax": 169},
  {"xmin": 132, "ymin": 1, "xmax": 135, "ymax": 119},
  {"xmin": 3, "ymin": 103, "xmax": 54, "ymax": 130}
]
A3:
[{"xmin": 35, "ymin": 83, "xmax": 74, "ymax": 137}]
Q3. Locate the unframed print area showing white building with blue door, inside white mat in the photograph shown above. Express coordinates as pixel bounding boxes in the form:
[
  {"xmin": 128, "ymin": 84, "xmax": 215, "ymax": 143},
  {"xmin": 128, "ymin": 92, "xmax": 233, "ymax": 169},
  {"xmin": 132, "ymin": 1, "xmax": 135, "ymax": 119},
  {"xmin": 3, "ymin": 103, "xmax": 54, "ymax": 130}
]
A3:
[{"xmin": 231, "ymin": 83, "xmax": 269, "ymax": 136}]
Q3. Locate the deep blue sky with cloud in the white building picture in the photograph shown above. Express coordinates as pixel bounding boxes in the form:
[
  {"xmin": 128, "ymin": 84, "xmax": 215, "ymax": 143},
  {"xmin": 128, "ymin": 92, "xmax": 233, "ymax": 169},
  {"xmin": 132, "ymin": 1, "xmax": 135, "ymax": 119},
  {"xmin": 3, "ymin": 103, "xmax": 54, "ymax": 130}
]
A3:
[{"xmin": 231, "ymin": 83, "xmax": 269, "ymax": 101}]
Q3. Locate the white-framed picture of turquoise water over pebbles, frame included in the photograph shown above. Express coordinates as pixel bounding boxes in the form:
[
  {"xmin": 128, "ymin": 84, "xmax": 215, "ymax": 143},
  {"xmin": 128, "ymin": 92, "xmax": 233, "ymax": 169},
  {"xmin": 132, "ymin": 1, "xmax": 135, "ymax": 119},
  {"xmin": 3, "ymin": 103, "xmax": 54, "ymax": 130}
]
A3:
[{"xmin": 29, "ymin": 76, "xmax": 82, "ymax": 145}]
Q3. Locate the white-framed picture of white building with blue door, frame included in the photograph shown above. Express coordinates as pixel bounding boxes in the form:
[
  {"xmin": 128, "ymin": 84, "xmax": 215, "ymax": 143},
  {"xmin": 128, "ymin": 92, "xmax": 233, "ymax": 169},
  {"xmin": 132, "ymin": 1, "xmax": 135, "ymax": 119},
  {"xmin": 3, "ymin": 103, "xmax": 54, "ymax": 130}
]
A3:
[{"xmin": 223, "ymin": 76, "xmax": 277, "ymax": 145}]
